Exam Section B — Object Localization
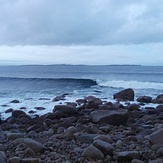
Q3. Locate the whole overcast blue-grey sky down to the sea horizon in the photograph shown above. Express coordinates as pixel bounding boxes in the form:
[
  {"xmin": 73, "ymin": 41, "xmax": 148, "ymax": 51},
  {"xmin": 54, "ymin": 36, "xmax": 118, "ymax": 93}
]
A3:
[{"xmin": 0, "ymin": 0, "xmax": 163, "ymax": 65}]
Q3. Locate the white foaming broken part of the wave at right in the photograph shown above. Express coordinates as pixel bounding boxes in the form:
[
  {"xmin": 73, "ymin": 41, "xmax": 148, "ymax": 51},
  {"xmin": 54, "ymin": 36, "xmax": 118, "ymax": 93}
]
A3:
[{"xmin": 97, "ymin": 80, "xmax": 163, "ymax": 90}]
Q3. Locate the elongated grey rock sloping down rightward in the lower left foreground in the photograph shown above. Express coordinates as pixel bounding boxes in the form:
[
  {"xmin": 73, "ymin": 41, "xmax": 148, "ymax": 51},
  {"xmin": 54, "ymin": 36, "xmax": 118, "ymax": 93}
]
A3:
[{"xmin": 24, "ymin": 138, "xmax": 46, "ymax": 153}]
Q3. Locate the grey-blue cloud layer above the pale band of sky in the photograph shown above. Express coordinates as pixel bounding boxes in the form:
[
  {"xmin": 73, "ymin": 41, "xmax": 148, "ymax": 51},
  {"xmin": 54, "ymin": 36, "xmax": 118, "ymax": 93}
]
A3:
[{"xmin": 0, "ymin": 0, "xmax": 163, "ymax": 45}]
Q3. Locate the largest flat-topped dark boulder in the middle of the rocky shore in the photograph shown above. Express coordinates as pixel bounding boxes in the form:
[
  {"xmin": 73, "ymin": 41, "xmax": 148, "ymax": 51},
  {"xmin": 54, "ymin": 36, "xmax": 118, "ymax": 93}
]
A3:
[{"xmin": 91, "ymin": 109, "xmax": 128, "ymax": 126}]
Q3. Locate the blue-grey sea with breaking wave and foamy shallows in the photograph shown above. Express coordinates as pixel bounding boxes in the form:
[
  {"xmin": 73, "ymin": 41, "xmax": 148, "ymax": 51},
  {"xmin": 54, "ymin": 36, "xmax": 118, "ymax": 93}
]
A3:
[{"xmin": 0, "ymin": 65, "xmax": 163, "ymax": 119}]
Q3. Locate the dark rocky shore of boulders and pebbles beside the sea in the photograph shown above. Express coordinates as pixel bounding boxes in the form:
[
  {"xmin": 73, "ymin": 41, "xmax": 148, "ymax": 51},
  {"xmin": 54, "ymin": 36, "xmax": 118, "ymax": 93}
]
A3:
[{"xmin": 0, "ymin": 89, "xmax": 163, "ymax": 163}]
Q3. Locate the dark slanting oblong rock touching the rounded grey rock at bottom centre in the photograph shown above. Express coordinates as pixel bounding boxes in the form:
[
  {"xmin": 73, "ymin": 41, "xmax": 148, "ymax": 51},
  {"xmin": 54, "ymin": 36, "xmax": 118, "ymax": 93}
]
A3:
[{"xmin": 93, "ymin": 139, "xmax": 114, "ymax": 156}]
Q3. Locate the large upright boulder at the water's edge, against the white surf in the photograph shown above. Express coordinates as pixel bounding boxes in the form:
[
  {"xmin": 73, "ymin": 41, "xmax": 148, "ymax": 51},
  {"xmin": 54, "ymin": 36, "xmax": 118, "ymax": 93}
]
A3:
[{"xmin": 113, "ymin": 88, "xmax": 134, "ymax": 101}]
